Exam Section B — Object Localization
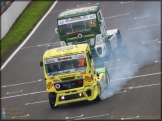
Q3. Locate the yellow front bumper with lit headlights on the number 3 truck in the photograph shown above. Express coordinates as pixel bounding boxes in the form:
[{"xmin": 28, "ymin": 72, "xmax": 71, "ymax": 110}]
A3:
[{"xmin": 55, "ymin": 85, "xmax": 99, "ymax": 106}]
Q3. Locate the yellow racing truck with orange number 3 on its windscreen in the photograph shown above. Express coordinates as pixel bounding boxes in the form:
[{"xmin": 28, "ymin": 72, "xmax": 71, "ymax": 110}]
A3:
[{"xmin": 40, "ymin": 43, "xmax": 110, "ymax": 109}]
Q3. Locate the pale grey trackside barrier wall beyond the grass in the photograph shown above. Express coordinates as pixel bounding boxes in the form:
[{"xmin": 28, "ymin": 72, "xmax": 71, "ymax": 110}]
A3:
[{"xmin": 1, "ymin": 0, "xmax": 31, "ymax": 39}]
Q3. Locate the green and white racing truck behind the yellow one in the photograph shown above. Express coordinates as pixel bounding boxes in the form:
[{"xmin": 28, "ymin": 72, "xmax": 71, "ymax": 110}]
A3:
[{"xmin": 55, "ymin": 6, "xmax": 122, "ymax": 57}]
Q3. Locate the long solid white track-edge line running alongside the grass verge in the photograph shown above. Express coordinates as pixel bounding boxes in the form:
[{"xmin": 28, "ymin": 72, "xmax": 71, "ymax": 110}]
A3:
[{"xmin": 1, "ymin": 0, "xmax": 58, "ymax": 70}]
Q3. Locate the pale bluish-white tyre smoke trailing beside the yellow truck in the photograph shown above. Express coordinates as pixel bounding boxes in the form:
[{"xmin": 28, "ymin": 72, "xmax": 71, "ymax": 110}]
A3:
[{"xmin": 97, "ymin": 3, "xmax": 161, "ymax": 99}]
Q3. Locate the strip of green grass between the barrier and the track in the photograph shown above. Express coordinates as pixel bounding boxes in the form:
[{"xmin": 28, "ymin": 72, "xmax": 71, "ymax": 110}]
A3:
[{"xmin": 0, "ymin": 0, "xmax": 53, "ymax": 58}]
